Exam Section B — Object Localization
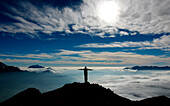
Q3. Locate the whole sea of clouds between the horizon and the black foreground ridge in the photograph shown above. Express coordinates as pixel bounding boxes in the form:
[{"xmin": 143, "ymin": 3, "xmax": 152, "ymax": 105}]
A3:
[{"xmin": 0, "ymin": 67, "xmax": 170, "ymax": 102}]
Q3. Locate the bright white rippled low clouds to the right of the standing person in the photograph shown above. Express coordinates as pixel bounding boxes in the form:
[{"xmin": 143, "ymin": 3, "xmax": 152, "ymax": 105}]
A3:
[{"xmin": 92, "ymin": 69, "xmax": 170, "ymax": 100}]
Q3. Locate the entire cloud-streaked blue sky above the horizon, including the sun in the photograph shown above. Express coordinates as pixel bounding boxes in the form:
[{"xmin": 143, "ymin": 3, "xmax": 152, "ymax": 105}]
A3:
[{"xmin": 0, "ymin": 0, "xmax": 170, "ymax": 66}]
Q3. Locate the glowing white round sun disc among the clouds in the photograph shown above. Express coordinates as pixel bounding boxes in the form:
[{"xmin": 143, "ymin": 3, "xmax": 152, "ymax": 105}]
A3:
[{"xmin": 98, "ymin": 1, "xmax": 119, "ymax": 23}]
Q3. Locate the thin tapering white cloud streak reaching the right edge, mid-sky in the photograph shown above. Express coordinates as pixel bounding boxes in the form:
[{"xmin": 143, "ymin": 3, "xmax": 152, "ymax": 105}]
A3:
[{"xmin": 76, "ymin": 35, "xmax": 170, "ymax": 50}]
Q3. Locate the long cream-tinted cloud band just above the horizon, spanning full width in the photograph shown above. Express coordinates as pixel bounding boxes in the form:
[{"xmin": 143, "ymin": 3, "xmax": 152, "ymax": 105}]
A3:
[{"xmin": 0, "ymin": 50, "xmax": 170, "ymax": 66}]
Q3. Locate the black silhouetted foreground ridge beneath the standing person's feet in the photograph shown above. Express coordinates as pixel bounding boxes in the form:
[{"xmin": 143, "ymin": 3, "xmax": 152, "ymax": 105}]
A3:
[{"xmin": 0, "ymin": 83, "xmax": 170, "ymax": 106}]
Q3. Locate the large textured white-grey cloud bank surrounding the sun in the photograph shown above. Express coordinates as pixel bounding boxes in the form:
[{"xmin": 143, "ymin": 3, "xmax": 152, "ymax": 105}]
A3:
[{"xmin": 0, "ymin": 0, "xmax": 170, "ymax": 37}]
